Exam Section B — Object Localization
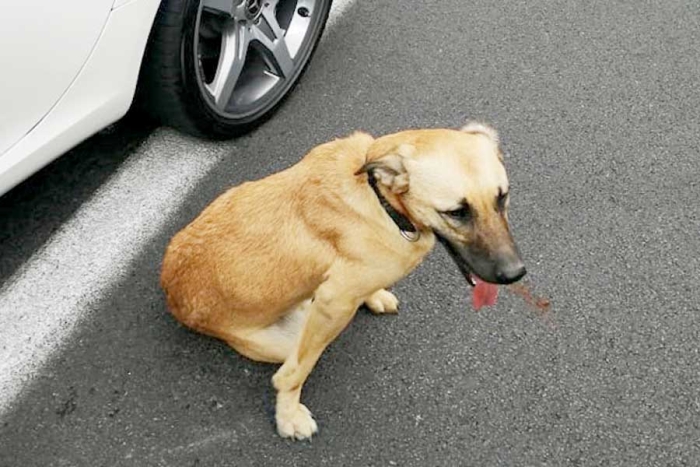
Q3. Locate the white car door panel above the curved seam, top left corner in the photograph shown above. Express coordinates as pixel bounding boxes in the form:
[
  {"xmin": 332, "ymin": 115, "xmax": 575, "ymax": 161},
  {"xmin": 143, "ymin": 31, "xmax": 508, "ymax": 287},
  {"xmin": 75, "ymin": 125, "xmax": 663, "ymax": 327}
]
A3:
[{"xmin": 0, "ymin": 0, "xmax": 114, "ymax": 154}]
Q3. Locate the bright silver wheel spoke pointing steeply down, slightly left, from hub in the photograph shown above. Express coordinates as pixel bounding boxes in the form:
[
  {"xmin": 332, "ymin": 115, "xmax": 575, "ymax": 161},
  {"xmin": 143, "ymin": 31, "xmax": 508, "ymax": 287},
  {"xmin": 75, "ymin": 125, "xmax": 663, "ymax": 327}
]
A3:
[{"xmin": 207, "ymin": 25, "xmax": 250, "ymax": 109}]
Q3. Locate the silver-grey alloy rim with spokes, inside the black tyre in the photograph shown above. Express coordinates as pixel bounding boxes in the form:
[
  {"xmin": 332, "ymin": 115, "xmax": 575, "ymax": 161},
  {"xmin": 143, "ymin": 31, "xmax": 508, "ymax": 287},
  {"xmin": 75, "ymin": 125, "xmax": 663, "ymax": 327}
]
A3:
[{"xmin": 194, "ymin": 0, "xmax": 323, "ymax": 119}]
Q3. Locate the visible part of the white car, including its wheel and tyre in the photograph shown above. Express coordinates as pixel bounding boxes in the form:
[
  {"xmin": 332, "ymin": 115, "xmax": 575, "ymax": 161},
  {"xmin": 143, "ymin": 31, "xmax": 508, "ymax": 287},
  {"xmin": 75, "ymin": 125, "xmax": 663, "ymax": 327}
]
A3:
[{"xmin": 0, "ymin": 0, "xmax": 331, "ymax": 195}]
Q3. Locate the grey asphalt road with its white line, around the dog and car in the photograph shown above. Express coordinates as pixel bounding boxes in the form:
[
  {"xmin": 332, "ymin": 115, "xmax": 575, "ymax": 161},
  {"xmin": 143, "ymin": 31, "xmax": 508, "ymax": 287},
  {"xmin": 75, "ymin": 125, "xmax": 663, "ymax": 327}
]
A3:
[{"xmin": 0, "ymin": 0, "xmax": 700, "ymax": 467}]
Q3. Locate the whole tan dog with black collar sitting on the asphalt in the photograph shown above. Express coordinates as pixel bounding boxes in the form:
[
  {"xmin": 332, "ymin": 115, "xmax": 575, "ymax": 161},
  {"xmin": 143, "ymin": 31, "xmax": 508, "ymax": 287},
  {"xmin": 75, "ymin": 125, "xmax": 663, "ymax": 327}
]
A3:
[{"xmin": 161, "ymin": 123, "xmax": 525, "ymax": 439}]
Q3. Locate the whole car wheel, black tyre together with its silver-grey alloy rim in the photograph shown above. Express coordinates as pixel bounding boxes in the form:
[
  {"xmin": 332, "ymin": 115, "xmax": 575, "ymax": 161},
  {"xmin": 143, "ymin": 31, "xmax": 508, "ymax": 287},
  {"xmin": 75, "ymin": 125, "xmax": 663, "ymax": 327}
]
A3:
[{"xmin": 136, "ymin": 0, "xmax": 332, "ymax": 139}]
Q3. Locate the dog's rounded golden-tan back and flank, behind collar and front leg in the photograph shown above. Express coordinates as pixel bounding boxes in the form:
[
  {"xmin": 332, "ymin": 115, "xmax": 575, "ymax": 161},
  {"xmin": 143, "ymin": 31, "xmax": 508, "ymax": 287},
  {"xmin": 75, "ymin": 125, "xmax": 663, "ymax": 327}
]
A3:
[{"xmin": 161, "ymin": 133, "xmax": 373, "ymax": 340}]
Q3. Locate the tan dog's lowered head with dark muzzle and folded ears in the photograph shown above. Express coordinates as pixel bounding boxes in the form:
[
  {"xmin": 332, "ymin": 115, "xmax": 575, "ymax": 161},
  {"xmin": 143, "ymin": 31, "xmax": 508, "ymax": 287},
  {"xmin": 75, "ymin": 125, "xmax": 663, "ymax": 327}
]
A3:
[{"xmin": 362, "ymin": 123, "xmax": 525, "ymax": 285}]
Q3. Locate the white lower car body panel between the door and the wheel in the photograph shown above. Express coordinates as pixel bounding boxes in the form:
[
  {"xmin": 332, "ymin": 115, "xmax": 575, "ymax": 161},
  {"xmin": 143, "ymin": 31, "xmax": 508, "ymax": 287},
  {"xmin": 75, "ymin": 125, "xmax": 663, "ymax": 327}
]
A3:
[{"xmin": 0, "ymin": 0, "xmax": 160, "ymax": 195}]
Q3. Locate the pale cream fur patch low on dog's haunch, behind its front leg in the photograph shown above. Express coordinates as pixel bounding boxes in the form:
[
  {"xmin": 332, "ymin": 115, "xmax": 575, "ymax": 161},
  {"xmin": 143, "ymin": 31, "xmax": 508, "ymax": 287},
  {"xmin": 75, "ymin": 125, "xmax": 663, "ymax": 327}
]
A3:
[{"xmin": 226, "ymin": 300, "xmax": 311, "ymax": 363}]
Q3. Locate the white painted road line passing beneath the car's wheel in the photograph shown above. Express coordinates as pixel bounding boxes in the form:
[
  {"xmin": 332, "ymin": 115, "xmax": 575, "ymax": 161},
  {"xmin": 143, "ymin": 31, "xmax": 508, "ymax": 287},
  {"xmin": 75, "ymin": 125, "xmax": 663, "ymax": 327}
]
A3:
[{"xmin": 0, "ymin": 0, "xmax": 353, "ymax": 417}]
